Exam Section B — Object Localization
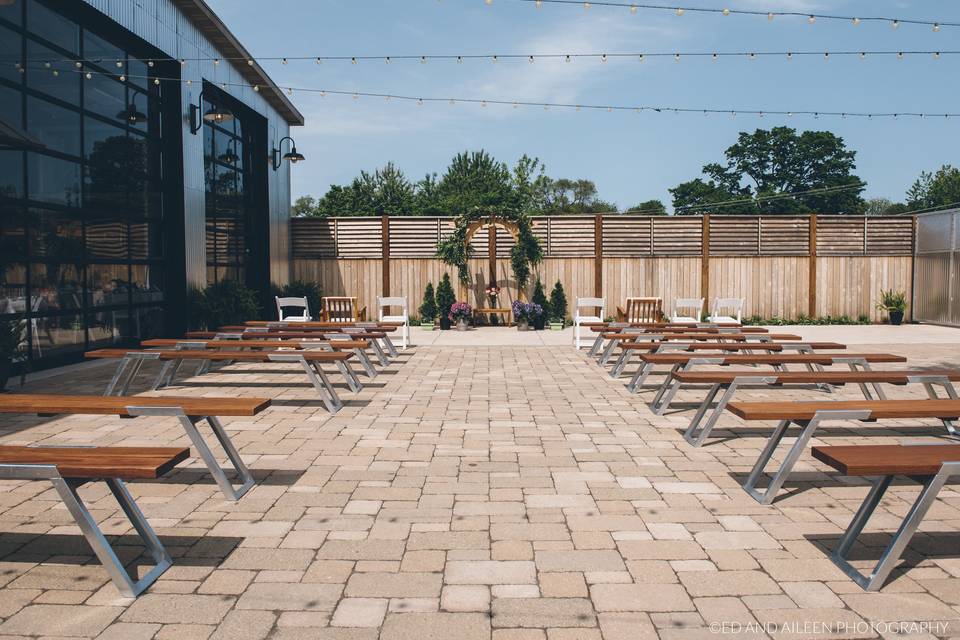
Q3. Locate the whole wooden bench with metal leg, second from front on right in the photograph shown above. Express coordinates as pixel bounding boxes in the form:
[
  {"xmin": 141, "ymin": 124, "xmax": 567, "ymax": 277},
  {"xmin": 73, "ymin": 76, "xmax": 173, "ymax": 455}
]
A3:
[{"xmin": 727, "ymin": 398, "xmax": 960, "ymax": 504}]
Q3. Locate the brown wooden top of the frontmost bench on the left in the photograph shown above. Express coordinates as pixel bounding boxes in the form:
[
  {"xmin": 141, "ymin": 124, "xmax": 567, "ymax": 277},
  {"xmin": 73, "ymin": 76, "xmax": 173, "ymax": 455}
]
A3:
[{"xmin": 0, "ymin": 446, "xmax": 190, "ymax": 480}]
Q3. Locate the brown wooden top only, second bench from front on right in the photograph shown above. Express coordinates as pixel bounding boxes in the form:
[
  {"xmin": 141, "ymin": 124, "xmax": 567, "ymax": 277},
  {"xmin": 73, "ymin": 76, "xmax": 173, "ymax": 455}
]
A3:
[{"xmin": 727, "ymin": 399, "xmax": 960, "ymax": 420}]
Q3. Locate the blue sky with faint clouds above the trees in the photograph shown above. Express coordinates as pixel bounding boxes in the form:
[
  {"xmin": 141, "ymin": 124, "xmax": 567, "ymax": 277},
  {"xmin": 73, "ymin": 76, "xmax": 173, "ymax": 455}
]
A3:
[{"xmin": 209, "ymin": 0, "xmax": 960, "ymax": 208}]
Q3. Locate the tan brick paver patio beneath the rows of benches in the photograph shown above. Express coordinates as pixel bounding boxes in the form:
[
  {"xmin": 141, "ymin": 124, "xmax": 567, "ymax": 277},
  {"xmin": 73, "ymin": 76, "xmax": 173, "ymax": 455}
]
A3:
[{"xmin": 0, "ymin": 328, "xmax": 960, "ymax": 640}]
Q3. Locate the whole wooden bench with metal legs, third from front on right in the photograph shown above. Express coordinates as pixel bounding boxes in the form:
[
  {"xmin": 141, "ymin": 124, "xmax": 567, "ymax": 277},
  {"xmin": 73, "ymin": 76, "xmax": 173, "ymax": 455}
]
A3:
[{"xmin": 673, "ymin": 370, "xmax": 960, "ymax": 447}]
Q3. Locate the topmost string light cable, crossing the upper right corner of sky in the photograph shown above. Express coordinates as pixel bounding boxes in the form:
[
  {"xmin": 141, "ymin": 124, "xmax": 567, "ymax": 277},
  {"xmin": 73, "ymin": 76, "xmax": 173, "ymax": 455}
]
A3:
[{"xmin": 496, "ymin": 0, "xmax": 960, "ymax": 32}]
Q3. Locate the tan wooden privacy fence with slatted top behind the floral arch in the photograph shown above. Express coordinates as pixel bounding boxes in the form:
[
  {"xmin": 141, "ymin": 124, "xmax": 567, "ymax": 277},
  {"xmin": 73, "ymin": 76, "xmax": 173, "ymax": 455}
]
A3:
[{"xmin": 291, "ymin": 215, "xmax": 914, "ymax": 320}]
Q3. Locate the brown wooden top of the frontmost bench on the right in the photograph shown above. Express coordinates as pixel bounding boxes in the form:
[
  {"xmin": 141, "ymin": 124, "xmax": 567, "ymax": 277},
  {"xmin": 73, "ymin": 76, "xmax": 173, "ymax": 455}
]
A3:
[{"xmin": 813, "ymin": 444, "xmax": 960, "ymax": 476}]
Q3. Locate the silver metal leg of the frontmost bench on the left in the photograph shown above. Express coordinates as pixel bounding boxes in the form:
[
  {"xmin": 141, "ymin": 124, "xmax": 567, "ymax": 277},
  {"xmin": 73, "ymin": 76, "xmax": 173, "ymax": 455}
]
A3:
[{"xmin": 56, "ymin": 468, "xmax": 173, "ymax": 598}]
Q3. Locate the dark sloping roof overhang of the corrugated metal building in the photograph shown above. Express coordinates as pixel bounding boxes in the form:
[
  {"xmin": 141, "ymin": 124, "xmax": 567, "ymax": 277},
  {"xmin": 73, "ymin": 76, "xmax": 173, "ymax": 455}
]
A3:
[{"xmin": 173, "ymin": 0, "xmax": 304, "ymax": 127}]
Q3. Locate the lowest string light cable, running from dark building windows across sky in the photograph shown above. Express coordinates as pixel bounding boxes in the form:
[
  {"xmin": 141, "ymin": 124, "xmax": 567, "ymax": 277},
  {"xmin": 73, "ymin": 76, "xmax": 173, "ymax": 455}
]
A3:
[{"xmin": 20, "ymin": 66, "xmax": 960, "ymax": 120}]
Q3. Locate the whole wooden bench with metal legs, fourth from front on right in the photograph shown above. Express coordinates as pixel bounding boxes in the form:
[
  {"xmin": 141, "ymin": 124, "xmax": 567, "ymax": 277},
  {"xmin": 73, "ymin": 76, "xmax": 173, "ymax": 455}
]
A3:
[{"xmin": 627, "ymin": 353, "xmax": 907, "ymax": 408}]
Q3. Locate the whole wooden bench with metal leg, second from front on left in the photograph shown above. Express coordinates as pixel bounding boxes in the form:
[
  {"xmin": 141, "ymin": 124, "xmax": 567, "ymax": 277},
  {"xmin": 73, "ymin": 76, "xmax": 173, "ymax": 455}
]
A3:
[{"xmin": 0, "ymin": 394, "xmax": 270, "ymax": 500}]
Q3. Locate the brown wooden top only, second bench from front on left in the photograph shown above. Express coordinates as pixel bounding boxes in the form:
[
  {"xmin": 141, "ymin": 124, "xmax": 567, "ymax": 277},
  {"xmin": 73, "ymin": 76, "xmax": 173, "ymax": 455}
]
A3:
[{"xmin": 0, "ymin": 393, "xmax": 270, "ymax": 416}]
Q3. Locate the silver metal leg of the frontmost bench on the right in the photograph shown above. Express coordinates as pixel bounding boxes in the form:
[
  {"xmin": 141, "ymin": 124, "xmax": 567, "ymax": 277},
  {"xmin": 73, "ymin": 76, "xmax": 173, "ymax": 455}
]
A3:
[{"xmin": 830, "ymin": 462, "xmax": 960, "ymax": 591}]
